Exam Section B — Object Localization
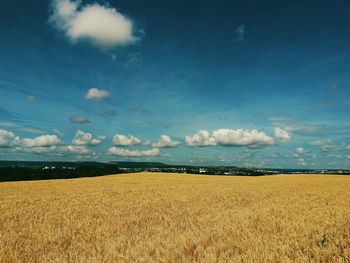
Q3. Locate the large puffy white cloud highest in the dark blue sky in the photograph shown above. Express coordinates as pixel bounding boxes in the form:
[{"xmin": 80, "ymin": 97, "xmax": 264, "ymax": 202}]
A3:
[{"xmin": 50, "ymin": 0, "xmax": 137, "ymax": 49}]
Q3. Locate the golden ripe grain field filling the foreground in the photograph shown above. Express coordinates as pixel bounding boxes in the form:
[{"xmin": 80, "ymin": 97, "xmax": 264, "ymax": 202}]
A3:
[{"xmin": 0, "ymin": 173, "xmax": 350, "ymax": 263}]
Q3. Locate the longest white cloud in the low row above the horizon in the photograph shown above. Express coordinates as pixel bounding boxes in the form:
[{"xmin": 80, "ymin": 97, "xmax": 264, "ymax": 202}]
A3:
[{"xmin": 185, "ymin": 129, "xmax": 275, "ymax": 148}]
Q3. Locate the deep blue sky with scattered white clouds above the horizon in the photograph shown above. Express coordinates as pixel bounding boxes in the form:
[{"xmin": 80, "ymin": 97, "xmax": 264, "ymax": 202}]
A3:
[{"xmin": 0, "ymin": 0, "xmax": 350, "ymax": 169}]
